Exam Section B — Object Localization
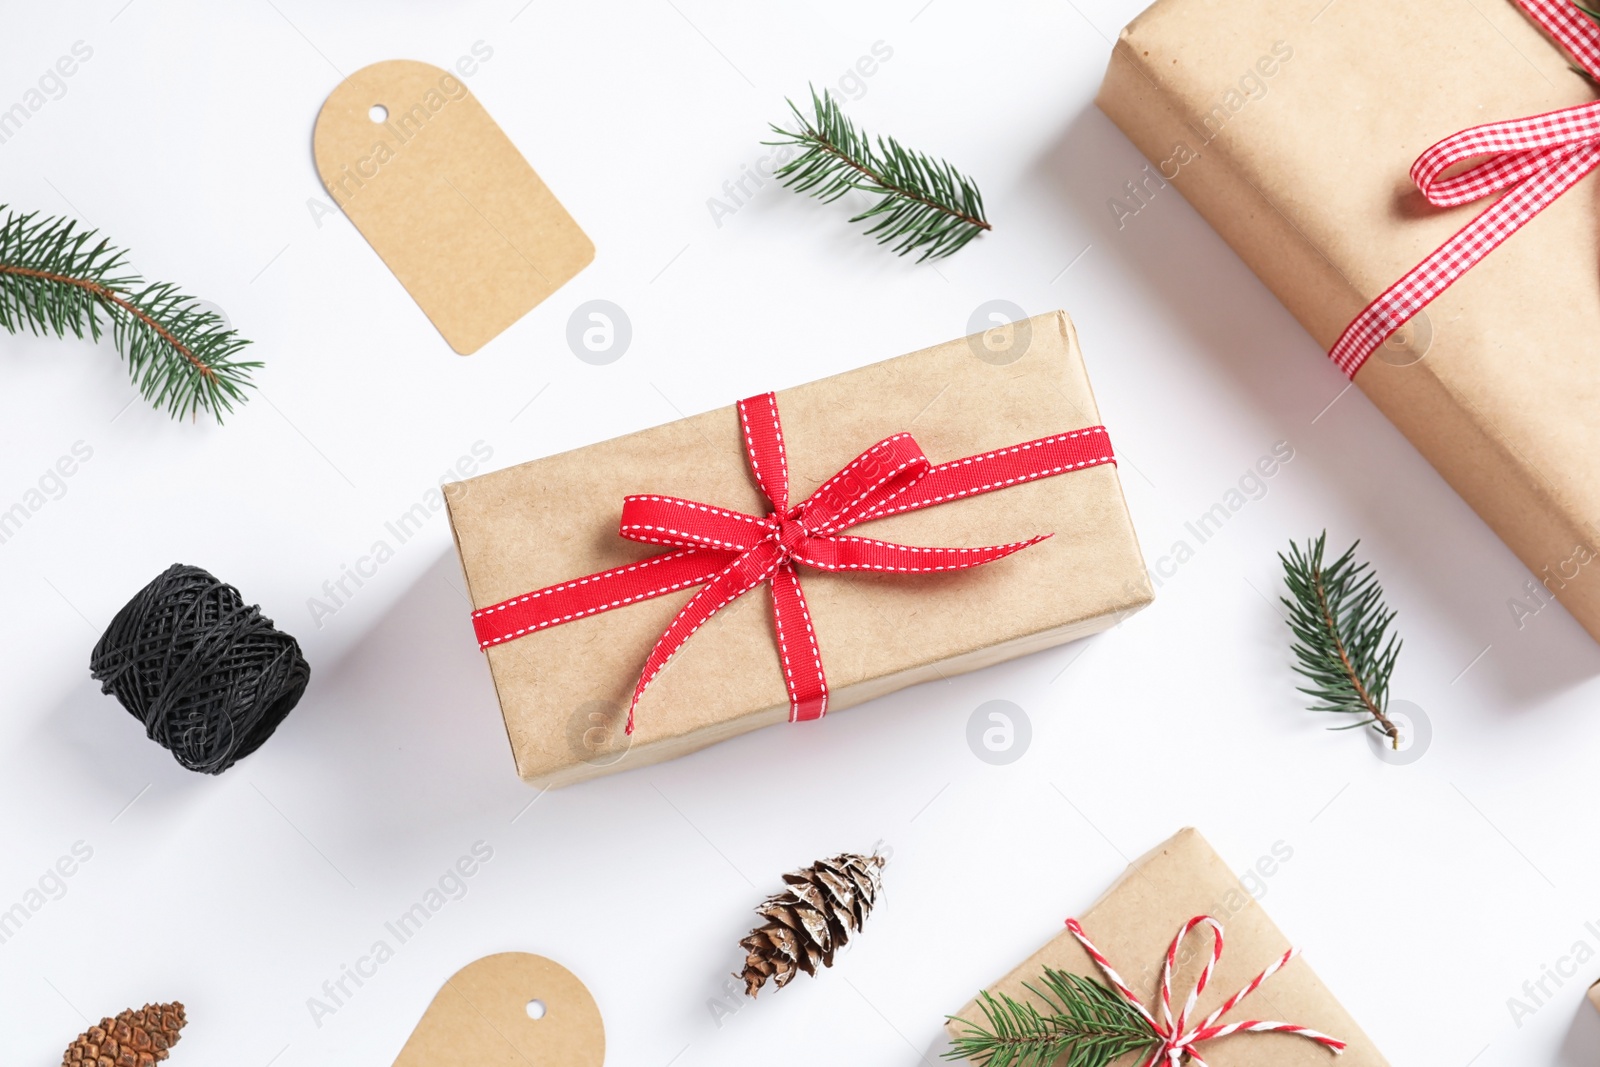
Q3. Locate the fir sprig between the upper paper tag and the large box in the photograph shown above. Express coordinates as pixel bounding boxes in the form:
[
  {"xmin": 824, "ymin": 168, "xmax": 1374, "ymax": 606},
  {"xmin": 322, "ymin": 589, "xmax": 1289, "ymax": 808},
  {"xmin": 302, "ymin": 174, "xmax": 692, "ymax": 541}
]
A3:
[{"xmin": 763, "ymin": 88, "xmax": 992, "ymax": 262}]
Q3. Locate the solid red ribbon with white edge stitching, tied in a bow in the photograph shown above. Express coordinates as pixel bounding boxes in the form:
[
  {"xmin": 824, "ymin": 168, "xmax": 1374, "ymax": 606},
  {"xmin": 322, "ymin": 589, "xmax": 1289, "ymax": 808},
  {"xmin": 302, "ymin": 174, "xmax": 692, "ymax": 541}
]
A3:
[{"xmin": 472, "ymin": 394, "xmax": 1117, "ymax": 733}]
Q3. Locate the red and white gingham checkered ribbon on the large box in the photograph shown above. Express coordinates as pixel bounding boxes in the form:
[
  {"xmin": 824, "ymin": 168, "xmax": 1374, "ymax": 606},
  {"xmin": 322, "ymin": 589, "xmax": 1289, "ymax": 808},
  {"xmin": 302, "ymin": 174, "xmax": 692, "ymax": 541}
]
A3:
[{"xmin": 1328, "ymin": 0, "xmax": 1600, "ymax": 378}]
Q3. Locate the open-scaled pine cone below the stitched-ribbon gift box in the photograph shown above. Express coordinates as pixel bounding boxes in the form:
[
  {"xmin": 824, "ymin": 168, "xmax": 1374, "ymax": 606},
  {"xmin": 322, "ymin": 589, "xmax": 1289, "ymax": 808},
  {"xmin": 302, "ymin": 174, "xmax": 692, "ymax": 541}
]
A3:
[{"xmin": 739, "ymin": 853, "xmax": 885, "ymax": 997}]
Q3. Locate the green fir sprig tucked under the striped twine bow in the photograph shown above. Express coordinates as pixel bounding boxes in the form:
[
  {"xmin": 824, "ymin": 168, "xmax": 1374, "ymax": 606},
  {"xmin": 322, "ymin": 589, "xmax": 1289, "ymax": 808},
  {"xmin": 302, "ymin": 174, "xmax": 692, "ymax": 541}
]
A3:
[{"xmin": 944, "ymin": 966, "xmax": 1160, "ymax": 1067}]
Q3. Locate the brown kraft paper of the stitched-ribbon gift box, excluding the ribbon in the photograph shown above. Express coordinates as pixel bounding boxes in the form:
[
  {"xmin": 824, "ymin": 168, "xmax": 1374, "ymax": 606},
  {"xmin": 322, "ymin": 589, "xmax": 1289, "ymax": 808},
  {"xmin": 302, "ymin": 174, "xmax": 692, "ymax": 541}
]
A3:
[{"xmin": 445, "ymin": 312, "xmax": 1154, "ymax": 785}]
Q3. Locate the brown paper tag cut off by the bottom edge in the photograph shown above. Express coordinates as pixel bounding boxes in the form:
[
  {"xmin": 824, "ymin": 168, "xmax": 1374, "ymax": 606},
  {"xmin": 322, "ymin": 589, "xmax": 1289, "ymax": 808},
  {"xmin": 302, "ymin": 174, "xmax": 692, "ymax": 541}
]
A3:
[{"xmin": 394, "ymin": 952, "xmax": 605, "ymax": 1067}]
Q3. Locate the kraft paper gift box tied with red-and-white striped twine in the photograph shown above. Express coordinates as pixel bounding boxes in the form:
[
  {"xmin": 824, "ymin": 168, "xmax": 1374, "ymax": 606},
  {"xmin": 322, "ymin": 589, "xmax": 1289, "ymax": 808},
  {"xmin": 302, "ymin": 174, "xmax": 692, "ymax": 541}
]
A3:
[{"xmin": 946, "ymin": 829, "xmax": 1387, "ymax": 1067}]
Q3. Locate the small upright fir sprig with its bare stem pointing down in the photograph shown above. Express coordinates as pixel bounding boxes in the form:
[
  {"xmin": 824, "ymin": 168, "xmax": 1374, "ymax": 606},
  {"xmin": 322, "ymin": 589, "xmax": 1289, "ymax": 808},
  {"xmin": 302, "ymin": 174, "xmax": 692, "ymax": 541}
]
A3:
[{"xmin": 1278, "ymin": 531, "xmax": 1400, "ymax": 749}]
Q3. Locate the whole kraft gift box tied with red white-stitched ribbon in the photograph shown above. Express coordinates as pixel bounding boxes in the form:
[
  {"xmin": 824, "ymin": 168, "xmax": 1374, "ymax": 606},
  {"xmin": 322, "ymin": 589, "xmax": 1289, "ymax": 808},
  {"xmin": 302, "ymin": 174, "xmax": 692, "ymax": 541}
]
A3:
[{"xmin": 446, "ymin": 312, "xmax": 1154, "ymax": 785}]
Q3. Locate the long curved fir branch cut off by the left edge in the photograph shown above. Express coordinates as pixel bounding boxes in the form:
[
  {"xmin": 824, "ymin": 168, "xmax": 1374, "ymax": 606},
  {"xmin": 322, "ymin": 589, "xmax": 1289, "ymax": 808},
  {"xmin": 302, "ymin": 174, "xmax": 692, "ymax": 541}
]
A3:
[{"xmin": 0, "ymin": 205, "xmax": 261, "ymax": 422}]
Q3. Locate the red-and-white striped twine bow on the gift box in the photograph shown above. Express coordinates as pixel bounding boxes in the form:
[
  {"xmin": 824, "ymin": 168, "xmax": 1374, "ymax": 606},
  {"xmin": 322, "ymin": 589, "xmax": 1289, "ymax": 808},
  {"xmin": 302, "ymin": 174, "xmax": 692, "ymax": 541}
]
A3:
[{"xmin": 1067, "ymin": 915, "xmax": 1346, "ymax": 1067}]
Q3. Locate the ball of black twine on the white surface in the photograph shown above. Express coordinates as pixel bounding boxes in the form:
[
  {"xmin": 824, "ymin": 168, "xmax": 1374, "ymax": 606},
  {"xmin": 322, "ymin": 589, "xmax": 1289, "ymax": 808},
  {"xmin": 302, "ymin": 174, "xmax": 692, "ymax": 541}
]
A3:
[{"xmin": 90, "ymin": 563, "xmax": 310, "ymax": 774}]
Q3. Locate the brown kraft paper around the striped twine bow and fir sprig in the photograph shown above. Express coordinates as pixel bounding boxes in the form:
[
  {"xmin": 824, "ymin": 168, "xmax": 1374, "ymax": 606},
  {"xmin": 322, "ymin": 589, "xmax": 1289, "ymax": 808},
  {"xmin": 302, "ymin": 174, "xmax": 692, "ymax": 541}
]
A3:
[{"xmin": 946, "ymin": 829, "xmax": 1389, "ymax": 1067}]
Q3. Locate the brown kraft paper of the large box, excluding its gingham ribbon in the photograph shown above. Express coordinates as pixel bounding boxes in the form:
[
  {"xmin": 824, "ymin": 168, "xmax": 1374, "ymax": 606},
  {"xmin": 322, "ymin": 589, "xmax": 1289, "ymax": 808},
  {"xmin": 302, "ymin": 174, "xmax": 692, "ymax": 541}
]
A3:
[{"xmin": 1098, "ymin": 0, "xmax": 1600, "ymax": 638}]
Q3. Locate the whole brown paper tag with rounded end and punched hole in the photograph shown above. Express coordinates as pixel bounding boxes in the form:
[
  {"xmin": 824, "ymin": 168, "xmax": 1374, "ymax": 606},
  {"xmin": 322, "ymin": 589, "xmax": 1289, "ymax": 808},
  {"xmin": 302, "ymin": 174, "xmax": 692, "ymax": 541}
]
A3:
[{"xmin": 312, "ymin": 59, "xmax": 595, "ymax": 355}]
